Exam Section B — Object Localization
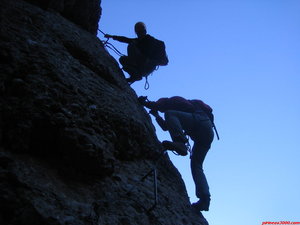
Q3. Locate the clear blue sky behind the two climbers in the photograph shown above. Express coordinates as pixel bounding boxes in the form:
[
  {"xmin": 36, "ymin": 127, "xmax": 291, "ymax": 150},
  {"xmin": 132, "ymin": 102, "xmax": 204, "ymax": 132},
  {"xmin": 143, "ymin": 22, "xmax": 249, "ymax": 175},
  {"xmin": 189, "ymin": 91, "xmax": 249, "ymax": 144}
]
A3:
[{"xmin": 99, "ymin": 0, "xmax": 300, "ymax": 225}]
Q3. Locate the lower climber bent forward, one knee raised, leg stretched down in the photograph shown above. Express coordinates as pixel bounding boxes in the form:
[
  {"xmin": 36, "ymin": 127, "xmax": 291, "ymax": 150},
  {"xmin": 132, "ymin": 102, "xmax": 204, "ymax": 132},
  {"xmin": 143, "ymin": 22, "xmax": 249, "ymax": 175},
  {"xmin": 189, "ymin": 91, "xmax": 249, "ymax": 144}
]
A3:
[{"xmin": 138, "ymin": 96, "xmax": 214, "ymax": 212}]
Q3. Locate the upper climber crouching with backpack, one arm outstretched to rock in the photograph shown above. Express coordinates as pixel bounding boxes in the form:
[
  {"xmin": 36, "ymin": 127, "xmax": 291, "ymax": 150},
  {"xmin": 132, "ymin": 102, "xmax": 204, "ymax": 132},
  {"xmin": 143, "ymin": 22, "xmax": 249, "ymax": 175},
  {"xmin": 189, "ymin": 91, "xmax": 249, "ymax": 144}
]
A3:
[{"xmin": 105, "ymin": 22, "xmax": 169, "ymax": 83}]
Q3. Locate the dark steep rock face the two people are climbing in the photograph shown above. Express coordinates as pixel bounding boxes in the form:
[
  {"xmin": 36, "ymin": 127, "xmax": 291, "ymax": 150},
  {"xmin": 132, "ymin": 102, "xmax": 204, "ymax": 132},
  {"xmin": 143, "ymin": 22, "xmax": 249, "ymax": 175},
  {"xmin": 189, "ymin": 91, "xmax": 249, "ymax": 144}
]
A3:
[{"xmin": 0, "ymin": 0, "xmax": 207, "ymax": 225}]
